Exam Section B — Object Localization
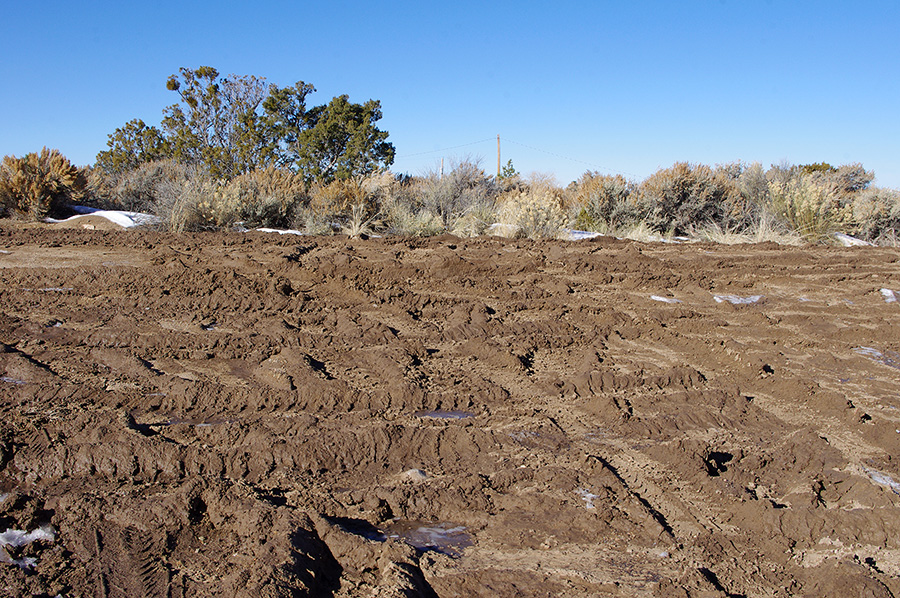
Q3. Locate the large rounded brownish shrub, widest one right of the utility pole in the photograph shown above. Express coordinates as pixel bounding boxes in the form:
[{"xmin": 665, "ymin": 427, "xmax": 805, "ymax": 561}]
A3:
[{"xmin": 637, "ymin": 162, "xmax": 746, "ymax": 234}]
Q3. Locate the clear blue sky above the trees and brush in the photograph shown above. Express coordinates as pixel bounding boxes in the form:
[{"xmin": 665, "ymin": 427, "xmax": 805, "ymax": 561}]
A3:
[{"xmin": 0, "ymin": 0, "xmax": 900, "ymax": 188}]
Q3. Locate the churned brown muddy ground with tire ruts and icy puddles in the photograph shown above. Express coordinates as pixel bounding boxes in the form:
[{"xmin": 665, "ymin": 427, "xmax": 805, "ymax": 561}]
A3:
[{"xmin": 0, "ymin": 222, "xmax": 900, "ymax": 598}]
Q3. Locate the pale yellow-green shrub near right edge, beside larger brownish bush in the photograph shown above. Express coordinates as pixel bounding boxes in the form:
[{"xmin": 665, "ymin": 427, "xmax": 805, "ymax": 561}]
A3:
[{"xmin": 769, "ymin": 175, "xmax": 853, "ymax": 243}]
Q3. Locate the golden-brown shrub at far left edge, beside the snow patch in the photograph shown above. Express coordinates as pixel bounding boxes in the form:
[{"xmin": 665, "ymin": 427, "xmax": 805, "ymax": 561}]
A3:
[{"xmin": 0, "ymin": 147, "xmax": 87, "ymax": 220}]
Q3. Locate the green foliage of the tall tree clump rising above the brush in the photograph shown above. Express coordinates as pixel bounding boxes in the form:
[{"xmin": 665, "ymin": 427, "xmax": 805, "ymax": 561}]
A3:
[{"xmin": 97, "ymin": 66, "xmax": 394, "ymax": 183}]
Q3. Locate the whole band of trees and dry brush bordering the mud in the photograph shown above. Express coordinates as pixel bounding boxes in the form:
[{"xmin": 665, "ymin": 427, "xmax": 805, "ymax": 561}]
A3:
[{"xmin": 0, "ymin": 67, "xmax": 900, "ymax": 246}]
